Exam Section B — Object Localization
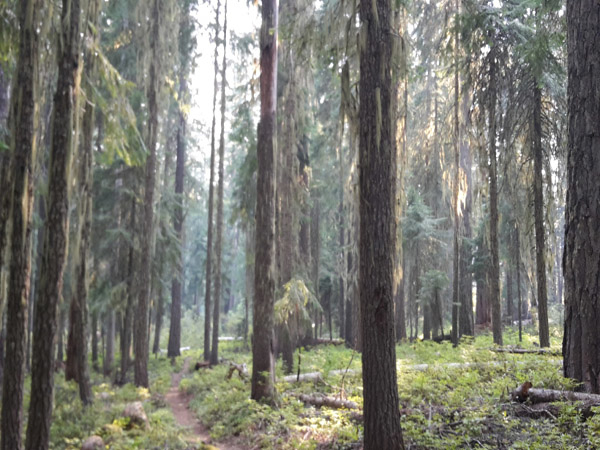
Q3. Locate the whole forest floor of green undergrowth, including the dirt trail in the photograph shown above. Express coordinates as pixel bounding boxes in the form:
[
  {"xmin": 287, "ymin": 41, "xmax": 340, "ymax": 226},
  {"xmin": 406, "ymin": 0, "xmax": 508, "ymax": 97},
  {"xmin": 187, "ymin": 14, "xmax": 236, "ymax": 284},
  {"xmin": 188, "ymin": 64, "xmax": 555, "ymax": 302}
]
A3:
[{"xmin": 44, "ymin": 328, "xmax": 600, "ymax": 450}]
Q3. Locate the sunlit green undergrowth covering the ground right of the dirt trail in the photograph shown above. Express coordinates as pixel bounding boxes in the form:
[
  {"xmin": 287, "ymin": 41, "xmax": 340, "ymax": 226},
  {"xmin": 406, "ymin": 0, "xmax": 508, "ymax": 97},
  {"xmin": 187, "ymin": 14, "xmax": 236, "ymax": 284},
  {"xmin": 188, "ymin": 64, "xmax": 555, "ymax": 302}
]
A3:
[{"xmin": 180, "ymin": 329, "xmax": 600, "ymax": 449}]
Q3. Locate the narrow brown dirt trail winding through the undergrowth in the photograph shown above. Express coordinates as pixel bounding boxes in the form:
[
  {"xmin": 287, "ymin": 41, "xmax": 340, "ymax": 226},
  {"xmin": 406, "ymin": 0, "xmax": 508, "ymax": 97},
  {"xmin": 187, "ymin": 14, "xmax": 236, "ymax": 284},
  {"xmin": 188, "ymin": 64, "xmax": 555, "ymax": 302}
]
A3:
[{"xmin": 165, "ymin": 356, "xmax": 239, "ymax": 450}]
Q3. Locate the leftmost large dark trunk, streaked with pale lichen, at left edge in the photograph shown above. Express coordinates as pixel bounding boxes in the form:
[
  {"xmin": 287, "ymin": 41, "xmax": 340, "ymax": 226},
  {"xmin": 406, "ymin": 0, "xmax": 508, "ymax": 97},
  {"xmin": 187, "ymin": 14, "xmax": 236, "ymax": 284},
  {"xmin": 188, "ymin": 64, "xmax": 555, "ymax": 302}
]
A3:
[{"xmin": 0, "ymin": 0, "xmax": 42, "ymax": 450}]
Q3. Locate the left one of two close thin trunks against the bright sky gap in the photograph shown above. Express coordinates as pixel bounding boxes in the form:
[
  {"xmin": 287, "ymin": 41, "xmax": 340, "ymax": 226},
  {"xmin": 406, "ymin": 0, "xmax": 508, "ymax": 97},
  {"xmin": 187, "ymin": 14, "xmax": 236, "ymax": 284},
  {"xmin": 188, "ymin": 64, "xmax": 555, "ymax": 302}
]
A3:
[{"xmin": 204, "ymin": 0, "xmax": 221, "ymax": 361}]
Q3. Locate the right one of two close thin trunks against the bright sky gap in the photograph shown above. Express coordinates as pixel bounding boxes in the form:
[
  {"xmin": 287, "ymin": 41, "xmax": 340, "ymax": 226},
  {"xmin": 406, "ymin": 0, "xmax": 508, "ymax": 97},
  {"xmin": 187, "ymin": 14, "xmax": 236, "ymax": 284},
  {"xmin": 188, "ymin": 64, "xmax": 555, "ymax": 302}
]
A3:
[{"xmin": 210, "ymin": 0, "xmax": 227, "ymax": 365}]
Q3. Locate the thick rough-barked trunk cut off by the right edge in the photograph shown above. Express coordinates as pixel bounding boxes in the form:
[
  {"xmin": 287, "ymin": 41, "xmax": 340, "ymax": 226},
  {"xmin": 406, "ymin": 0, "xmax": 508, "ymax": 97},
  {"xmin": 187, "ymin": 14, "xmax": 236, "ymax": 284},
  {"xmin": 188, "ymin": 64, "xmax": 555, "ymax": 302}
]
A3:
[{"xmin": 563, "ymin": 0, "xmax": 600, "ymax": 393}]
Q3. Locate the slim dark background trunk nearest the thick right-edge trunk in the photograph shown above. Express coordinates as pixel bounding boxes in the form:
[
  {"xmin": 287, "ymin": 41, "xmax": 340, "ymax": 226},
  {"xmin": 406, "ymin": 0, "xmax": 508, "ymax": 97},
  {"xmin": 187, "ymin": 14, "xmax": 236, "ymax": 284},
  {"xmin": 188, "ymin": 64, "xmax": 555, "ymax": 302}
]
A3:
[{"xmin": 532, "ymin": 85, "xmax": 550, "ymax": 347}]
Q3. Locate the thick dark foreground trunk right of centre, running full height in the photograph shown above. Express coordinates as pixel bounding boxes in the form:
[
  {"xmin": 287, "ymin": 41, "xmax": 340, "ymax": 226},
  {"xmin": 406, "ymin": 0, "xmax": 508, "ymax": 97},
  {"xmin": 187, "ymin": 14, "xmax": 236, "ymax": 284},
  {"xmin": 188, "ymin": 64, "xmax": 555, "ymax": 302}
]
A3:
[{"xmin": 359, "ymin": 0, "xmax": 404, "ymax": 450}]
